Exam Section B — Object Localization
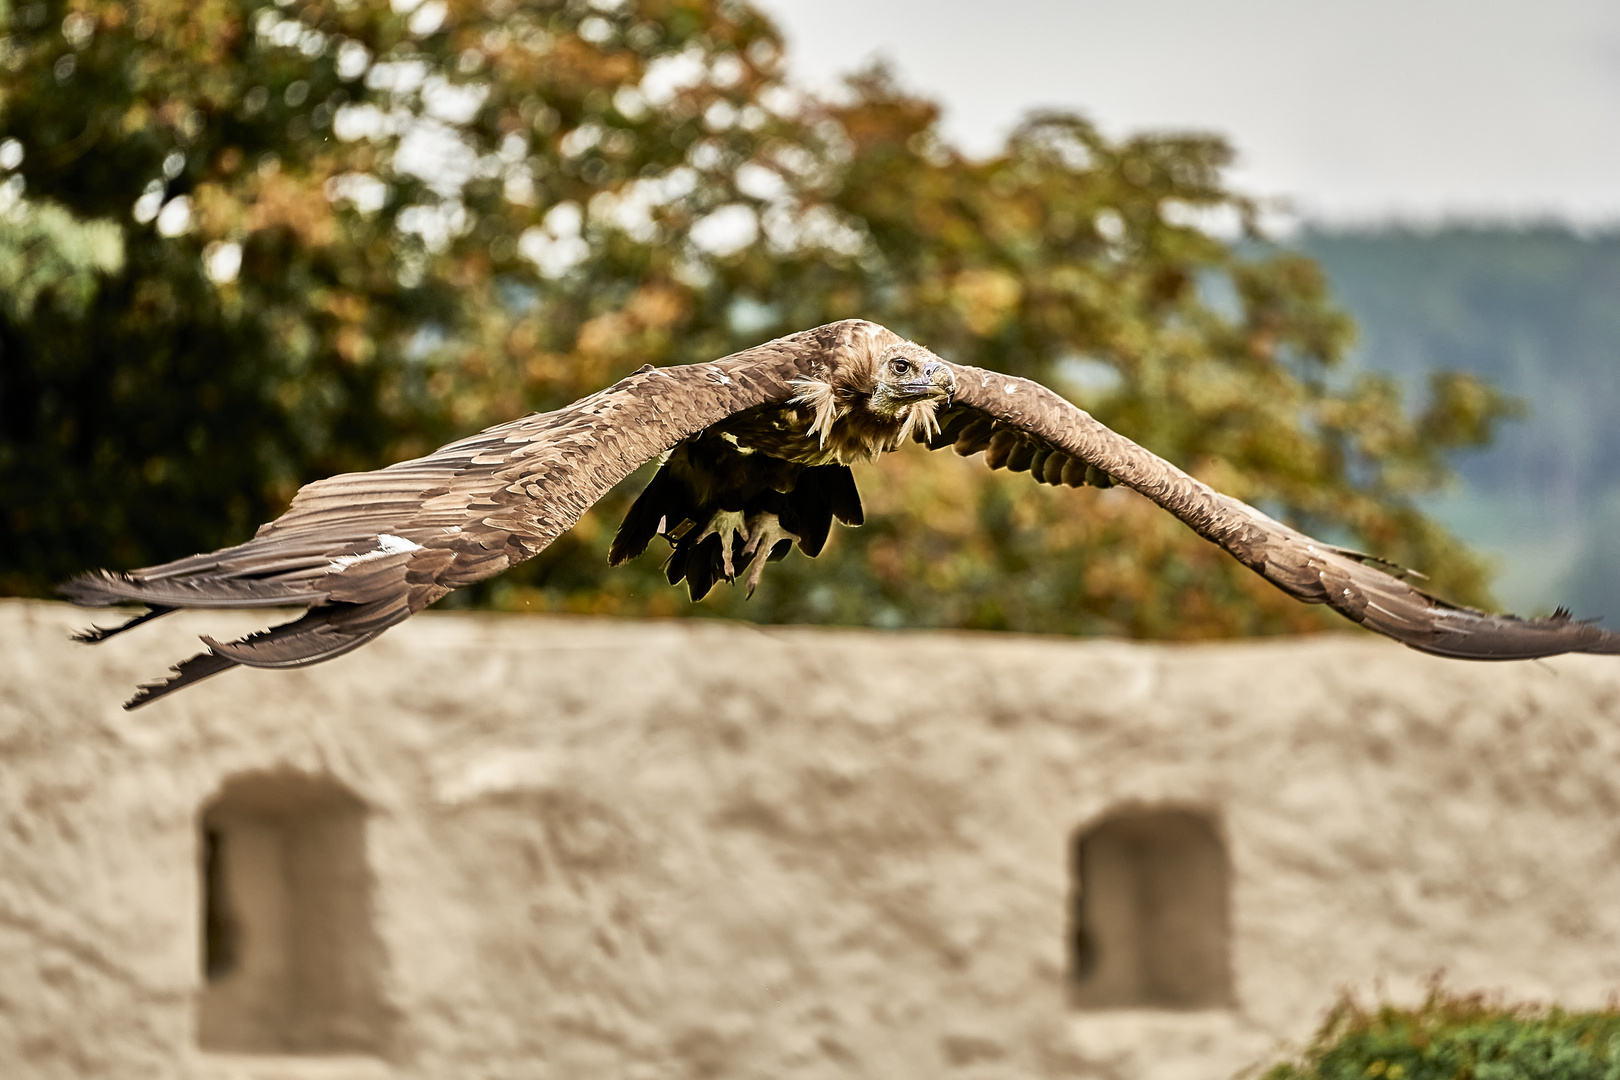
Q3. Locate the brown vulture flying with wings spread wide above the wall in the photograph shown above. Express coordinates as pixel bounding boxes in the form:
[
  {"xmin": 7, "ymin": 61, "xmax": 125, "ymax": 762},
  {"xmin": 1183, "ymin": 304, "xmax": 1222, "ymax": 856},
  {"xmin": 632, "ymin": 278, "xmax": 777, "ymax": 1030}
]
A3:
[{"xmin": 60, "ymin": 319, "xmax": 1620, "ymax": 709}]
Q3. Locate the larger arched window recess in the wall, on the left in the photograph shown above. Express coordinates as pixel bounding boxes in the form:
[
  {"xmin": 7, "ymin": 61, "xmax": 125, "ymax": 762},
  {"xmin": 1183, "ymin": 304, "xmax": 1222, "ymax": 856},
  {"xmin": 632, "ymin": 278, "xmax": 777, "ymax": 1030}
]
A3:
[{"xmin": 198, "ymin": 772, "xmax": 386, "ymax": 1054}]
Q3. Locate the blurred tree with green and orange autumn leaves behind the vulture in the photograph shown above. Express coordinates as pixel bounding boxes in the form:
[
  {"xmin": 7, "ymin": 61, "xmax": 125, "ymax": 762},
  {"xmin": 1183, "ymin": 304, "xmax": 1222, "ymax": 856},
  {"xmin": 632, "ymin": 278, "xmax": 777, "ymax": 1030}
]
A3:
[{"xmin": 0, "ymin": 0, "xmax": 1505, "ymax": 636}]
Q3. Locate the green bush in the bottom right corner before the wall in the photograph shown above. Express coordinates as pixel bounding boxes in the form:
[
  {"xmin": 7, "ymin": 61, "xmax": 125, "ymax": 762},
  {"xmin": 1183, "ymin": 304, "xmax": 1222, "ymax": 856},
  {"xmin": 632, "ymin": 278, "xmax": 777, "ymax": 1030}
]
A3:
[{"xmin": 1264, "ymin": 988, "xmax": 1620, "ymax": 1080}]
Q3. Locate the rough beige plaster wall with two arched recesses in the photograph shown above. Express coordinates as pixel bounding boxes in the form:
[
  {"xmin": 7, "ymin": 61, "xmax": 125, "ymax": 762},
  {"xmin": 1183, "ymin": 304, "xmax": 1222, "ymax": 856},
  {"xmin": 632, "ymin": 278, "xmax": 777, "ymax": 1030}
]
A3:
[{"xmin": 0, "ymin": 602, "xmax": 1620, "ymax": 1080}]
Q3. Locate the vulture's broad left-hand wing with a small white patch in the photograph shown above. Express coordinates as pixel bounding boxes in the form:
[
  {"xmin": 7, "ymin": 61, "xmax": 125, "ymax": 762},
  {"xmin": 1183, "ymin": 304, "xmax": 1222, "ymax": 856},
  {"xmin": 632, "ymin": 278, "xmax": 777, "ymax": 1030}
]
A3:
[{"xmin": 62, "ymin": 324, "xmax": 851, "ymax": 708}]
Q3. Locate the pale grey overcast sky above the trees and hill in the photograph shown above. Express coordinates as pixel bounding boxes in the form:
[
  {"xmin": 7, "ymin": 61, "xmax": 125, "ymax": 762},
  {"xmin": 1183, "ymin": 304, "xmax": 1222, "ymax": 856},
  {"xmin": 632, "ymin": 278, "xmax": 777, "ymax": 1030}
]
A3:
[{"xmin": 758, "ymin": 0, "xmax": 1620, "ymax": 223}]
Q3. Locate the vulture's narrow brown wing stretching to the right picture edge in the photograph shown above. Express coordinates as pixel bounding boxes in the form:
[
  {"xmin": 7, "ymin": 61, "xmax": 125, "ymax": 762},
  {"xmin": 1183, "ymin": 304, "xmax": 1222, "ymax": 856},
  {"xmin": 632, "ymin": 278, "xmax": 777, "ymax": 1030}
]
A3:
[{"xmin": 922, "ymin": 364, "xmax": 1620, "ymax": 661}]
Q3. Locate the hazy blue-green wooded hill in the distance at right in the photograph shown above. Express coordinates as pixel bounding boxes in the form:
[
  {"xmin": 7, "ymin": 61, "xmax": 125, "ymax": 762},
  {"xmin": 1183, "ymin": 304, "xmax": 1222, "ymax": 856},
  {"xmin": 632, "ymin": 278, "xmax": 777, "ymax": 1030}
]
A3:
[{"xmin": 1294, "ymin": 225, "xmax": 1620, "ymax": 623}]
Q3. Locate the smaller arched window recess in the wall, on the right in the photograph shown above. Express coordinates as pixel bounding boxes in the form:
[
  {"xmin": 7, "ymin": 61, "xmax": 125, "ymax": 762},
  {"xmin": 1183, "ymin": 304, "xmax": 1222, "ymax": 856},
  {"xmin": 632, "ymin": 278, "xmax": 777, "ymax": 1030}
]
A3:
[{"xmin": 1072, "ymin": 810, "xmax": 1231, "ymax": 1009}]
